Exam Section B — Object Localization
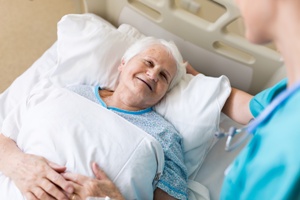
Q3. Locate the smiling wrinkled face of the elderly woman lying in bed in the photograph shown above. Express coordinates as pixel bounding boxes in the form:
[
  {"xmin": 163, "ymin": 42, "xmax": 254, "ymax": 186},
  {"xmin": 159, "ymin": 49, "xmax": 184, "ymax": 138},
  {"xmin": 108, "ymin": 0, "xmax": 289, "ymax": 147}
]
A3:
[{"xmin": 118, "ymin": 45, "xmax": 177, "ymax": 108}]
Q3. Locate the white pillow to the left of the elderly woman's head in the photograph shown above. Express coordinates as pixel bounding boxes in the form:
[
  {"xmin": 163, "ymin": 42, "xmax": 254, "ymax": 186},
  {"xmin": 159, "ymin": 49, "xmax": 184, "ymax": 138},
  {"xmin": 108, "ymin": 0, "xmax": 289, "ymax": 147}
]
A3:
[{"xmin": 52, "ymin": 14, "xmax": 136, "ymax": 89}]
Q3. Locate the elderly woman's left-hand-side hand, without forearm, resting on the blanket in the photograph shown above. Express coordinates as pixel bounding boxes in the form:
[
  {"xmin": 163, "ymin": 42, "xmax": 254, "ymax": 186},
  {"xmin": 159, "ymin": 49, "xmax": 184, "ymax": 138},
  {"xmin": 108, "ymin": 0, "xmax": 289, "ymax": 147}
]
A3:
[{"xmin": 10, "ymin": 154, "xmax": 73, "ymax": 199}]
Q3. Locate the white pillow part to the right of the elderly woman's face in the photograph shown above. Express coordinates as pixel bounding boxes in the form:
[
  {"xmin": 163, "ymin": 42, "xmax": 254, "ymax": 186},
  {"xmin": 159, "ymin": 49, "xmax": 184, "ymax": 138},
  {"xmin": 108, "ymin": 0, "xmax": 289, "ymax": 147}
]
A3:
[{"xmin": 154, "ymin": 74, "xmax": 231, "ymax": 179}]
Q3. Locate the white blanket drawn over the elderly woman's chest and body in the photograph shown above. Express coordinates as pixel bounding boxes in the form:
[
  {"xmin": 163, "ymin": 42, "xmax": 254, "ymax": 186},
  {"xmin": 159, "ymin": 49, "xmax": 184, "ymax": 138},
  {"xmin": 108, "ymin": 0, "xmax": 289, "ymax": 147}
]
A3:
[{"xmin": 0, "ymin": 82, "xmax": 164, "ymax": 200}]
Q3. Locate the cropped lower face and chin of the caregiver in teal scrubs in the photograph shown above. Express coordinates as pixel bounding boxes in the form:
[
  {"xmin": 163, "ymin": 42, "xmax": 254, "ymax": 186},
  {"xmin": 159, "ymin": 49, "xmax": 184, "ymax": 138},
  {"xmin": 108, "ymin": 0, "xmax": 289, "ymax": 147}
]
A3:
[{"xmin": 235, "ymin": 0, "xmax": 276, "ymax": 44}]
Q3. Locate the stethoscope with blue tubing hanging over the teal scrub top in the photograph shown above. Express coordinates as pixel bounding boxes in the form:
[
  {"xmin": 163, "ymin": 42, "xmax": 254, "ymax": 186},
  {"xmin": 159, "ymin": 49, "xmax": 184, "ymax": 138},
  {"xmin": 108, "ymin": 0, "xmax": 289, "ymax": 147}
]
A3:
[{"xmin": 215, "ymin": 82, "xmax": 300, "ymax": 151}]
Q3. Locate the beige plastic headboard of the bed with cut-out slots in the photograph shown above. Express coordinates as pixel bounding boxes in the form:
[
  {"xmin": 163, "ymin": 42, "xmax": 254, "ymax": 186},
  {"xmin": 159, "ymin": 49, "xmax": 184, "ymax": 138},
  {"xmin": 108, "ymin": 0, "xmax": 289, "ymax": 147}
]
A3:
[{"xmin": 84, "ymin": 0, "xmax": 285, "ymax": 94}]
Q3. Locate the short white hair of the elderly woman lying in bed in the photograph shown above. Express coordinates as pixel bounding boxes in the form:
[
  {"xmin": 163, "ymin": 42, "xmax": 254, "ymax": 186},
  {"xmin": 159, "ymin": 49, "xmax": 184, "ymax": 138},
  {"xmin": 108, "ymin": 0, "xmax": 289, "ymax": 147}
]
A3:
[{"xmin": 122, "ymin": 37, "xmax": 186, "ymax": 91}]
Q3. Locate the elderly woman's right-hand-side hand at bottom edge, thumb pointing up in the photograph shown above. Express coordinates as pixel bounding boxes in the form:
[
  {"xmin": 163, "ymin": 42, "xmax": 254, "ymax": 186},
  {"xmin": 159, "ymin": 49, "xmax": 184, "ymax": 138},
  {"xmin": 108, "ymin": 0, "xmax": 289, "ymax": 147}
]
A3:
[{"xmin": 63, "ymin": 163, "xmax": 124, "ymax": 200}]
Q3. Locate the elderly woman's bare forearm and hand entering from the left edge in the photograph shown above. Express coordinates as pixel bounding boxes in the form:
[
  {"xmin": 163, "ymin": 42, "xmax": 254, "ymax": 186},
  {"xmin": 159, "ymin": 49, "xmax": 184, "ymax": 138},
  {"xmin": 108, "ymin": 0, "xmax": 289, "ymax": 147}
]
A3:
[{"xmin": 0, "ymin": 134, "xmax": 73, "ymax": 199}]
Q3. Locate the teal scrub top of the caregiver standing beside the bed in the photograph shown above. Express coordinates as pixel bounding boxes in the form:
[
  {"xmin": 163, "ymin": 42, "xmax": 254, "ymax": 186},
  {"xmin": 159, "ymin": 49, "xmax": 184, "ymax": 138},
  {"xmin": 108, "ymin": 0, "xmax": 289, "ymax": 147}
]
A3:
[{"xmin": 220, "ymin": 79, "xmax": 300, "ymax": 200}]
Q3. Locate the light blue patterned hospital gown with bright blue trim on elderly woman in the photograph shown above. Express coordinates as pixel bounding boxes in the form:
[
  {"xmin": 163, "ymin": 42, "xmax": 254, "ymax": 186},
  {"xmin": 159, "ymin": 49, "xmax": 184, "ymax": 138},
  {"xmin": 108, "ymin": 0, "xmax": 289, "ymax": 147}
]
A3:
[{"xmin": 68, "ymin": 85, "xmax": 188, "ymax": 199}]
